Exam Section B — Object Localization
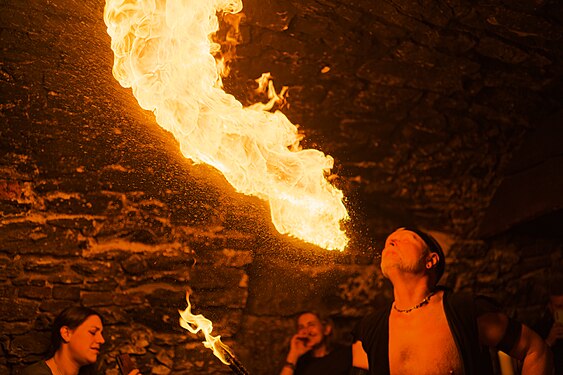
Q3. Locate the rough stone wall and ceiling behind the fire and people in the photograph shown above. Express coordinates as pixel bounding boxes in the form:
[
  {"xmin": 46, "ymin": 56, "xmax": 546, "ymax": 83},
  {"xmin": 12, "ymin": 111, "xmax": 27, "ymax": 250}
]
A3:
[{"xmin": 0, "ymin": 0, "xmax": 563, "ymax": 374}]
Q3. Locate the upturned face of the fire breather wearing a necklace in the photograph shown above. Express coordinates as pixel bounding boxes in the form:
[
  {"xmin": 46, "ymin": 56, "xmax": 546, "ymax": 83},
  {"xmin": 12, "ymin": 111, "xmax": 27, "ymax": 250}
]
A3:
[{"xmin": 381, "ymin": 229, "xmax": 428, "ymax": 278}]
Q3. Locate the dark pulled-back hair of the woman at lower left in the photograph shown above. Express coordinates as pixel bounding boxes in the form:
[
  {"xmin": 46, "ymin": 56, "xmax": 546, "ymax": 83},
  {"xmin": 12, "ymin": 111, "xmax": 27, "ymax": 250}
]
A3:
[{"xmin": 51, "ymin": 306, "xmax": 104, "ymax": 374}]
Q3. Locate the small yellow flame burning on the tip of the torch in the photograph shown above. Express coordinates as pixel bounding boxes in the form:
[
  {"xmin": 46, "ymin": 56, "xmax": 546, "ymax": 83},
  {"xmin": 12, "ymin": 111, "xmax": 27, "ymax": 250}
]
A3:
[{"xmin": 178, "ymin": 293, "xmax": 233, "ymax": 365}]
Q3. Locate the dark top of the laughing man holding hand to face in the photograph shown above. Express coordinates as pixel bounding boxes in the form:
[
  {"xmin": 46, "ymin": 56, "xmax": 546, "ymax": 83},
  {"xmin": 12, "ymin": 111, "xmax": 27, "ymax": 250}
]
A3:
[{"xmin": 294, "ymin": 346, "xmax": 352, "ymax": 375}]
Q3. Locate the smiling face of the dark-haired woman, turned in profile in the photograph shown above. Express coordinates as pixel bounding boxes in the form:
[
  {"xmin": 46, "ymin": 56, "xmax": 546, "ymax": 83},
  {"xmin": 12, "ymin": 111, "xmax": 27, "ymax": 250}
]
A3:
[{"xmin": 67, "ymin": 315, "xmax": 105, "ymax": 366}]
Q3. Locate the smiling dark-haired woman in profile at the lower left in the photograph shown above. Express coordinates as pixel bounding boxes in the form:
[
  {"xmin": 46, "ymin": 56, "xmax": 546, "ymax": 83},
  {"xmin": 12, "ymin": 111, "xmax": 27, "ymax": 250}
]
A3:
[{"xmin": 22, "ymin": 306, "xmax": 140, "ymax": 375}]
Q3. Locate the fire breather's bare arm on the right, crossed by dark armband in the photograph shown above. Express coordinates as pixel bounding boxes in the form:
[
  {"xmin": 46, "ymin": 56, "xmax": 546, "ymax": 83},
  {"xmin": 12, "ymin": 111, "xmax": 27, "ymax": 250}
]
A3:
[{"xmin": 477, "ymin": 313, "xmax": 553, "ymax": 375}]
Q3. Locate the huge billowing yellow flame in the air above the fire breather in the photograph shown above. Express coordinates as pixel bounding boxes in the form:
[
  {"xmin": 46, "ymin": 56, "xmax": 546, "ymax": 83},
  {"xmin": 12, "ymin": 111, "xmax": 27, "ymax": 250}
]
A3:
[{"xmin": 104, "ymin": 0, "xmax": 348, "ymax": 250}]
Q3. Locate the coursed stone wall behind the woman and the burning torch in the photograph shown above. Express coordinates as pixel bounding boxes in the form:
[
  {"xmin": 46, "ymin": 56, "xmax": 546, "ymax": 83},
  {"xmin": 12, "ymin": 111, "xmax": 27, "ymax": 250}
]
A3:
[{"xmin": 0, "ymin": 157, "xmax": 257, "ymax": 374}]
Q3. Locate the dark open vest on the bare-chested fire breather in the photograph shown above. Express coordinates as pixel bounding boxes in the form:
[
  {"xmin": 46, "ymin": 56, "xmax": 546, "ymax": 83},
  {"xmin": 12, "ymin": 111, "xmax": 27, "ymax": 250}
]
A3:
[{"xmin": 352, "ymin": 290, "xmax": 499, "ymax": 375}]
